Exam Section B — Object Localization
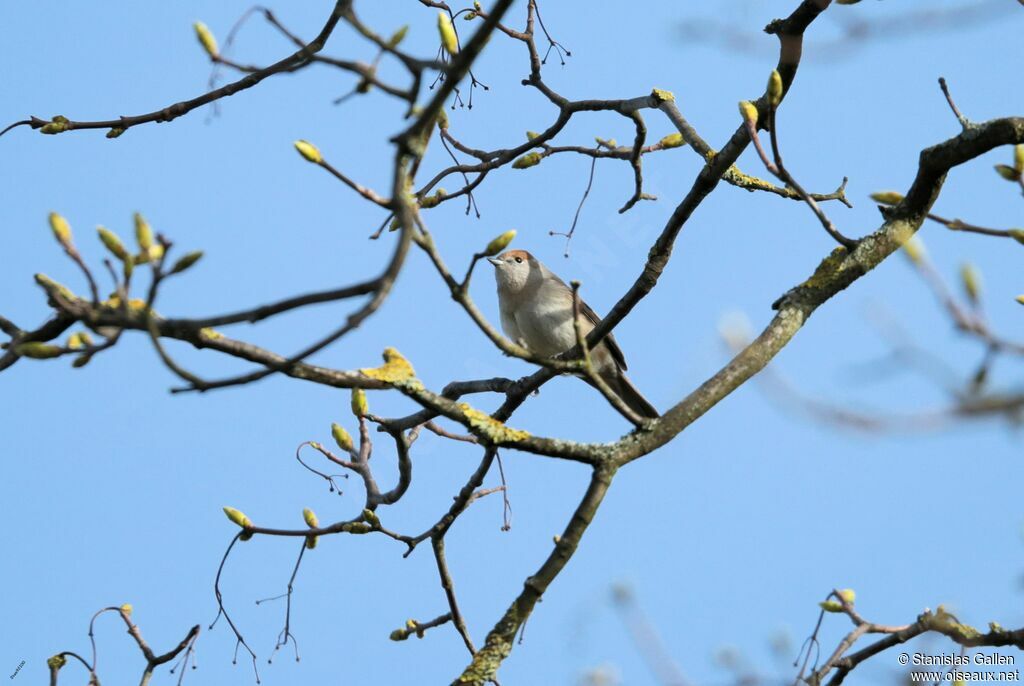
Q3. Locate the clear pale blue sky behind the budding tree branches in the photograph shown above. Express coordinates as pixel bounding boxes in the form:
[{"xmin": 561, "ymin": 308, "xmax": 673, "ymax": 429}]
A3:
[{"xmin": 0, "ymin": 0, "xmax": 1024, "ymax": 685}]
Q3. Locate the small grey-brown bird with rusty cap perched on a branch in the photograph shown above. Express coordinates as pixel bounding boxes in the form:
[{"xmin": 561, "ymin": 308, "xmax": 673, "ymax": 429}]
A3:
[{"xmin": 487, "ymin": 250, "xmax": 658, "ymax": 419}]
